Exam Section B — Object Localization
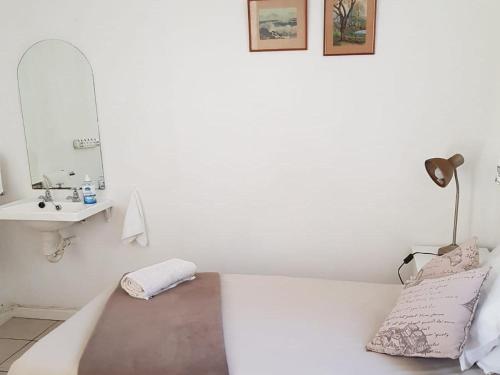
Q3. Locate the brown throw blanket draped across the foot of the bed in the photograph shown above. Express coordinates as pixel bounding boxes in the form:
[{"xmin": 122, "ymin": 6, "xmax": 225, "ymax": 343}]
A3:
[{"xmin": 78, "ymin": 273, "xmax": 229, "ymax": 375}]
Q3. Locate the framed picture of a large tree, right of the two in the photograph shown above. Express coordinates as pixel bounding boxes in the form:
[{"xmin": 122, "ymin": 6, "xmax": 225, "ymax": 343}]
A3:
[{"xmin": 323, "ymin": 0, "xmax": 377, "ymax": 56}]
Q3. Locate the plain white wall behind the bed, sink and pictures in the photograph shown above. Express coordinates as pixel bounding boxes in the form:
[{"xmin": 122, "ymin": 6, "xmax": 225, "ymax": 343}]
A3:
[{"xmin": 0, "ymin": 0, "xmax": 500, "ymax": 306}]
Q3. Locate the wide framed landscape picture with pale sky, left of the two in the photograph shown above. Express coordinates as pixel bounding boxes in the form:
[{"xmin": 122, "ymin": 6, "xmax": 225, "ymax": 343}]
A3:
[{"xmin": 247, "ymin": 0, "xmax": 307, "ymax": 52}]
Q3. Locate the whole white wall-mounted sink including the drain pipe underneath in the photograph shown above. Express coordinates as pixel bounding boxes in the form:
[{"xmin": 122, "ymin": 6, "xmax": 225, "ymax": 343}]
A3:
[{"xmin": 0, "ymin": 199, "xmax": 113, "ymax": 262}]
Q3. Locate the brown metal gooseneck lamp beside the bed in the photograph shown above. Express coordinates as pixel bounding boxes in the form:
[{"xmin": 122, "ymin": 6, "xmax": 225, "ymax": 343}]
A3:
[{"xmin": 425, "ymin": 154, "xmax": 464, "ymax": 255}]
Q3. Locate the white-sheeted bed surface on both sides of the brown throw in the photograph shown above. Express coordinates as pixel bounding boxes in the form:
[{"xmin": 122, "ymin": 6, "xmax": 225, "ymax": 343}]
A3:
[{"xmin": 9, "ymin": 275, "xmax": 482, "ymax": 375}]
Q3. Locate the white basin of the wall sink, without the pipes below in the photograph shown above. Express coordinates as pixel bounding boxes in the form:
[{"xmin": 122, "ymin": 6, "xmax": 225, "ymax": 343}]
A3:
[{"xmin": 0, "ymin": 199, "xmax": 112, "ymax": 232}]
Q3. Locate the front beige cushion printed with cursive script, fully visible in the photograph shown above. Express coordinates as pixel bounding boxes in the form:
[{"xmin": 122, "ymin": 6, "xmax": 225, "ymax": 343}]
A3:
[{"xmin": 366, "ymin": 268, "xmax": 489, "ymax": 358}]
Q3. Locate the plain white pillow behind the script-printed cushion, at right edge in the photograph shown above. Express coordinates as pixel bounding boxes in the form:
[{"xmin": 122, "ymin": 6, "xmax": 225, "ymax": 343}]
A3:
[{"xmin": 460, "ymin": 246, "xmax": 500, "ymax": 370}]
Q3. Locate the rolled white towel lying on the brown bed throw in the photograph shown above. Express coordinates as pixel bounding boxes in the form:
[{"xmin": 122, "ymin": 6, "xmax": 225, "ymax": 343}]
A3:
[{"xmin": 120, "ymin": 259, "xmax": 196, "ymax": 300}]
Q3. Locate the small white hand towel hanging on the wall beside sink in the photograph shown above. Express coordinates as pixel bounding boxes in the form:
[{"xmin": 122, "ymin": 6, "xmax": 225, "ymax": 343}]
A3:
[{"xmin": 122, "ymin": 190, "xmax": 148, "ymax": 247}]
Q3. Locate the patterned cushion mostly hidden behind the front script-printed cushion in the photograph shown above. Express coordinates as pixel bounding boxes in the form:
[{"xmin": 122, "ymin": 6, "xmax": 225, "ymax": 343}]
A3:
[{"xmin": 410, "ymin": 237, "xmax": 479, "ymax": 283}]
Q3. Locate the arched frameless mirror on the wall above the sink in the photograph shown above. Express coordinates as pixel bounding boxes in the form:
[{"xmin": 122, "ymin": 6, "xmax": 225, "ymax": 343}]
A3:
[{"xmin": 17, "ymin": 40, "xmax": 105, "ymax": 189}]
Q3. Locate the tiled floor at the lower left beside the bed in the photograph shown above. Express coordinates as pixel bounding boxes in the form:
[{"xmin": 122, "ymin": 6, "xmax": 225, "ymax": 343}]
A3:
[{"xmin": 0, "ymin": 318, "xmax": 62, "ymax": 375}]
